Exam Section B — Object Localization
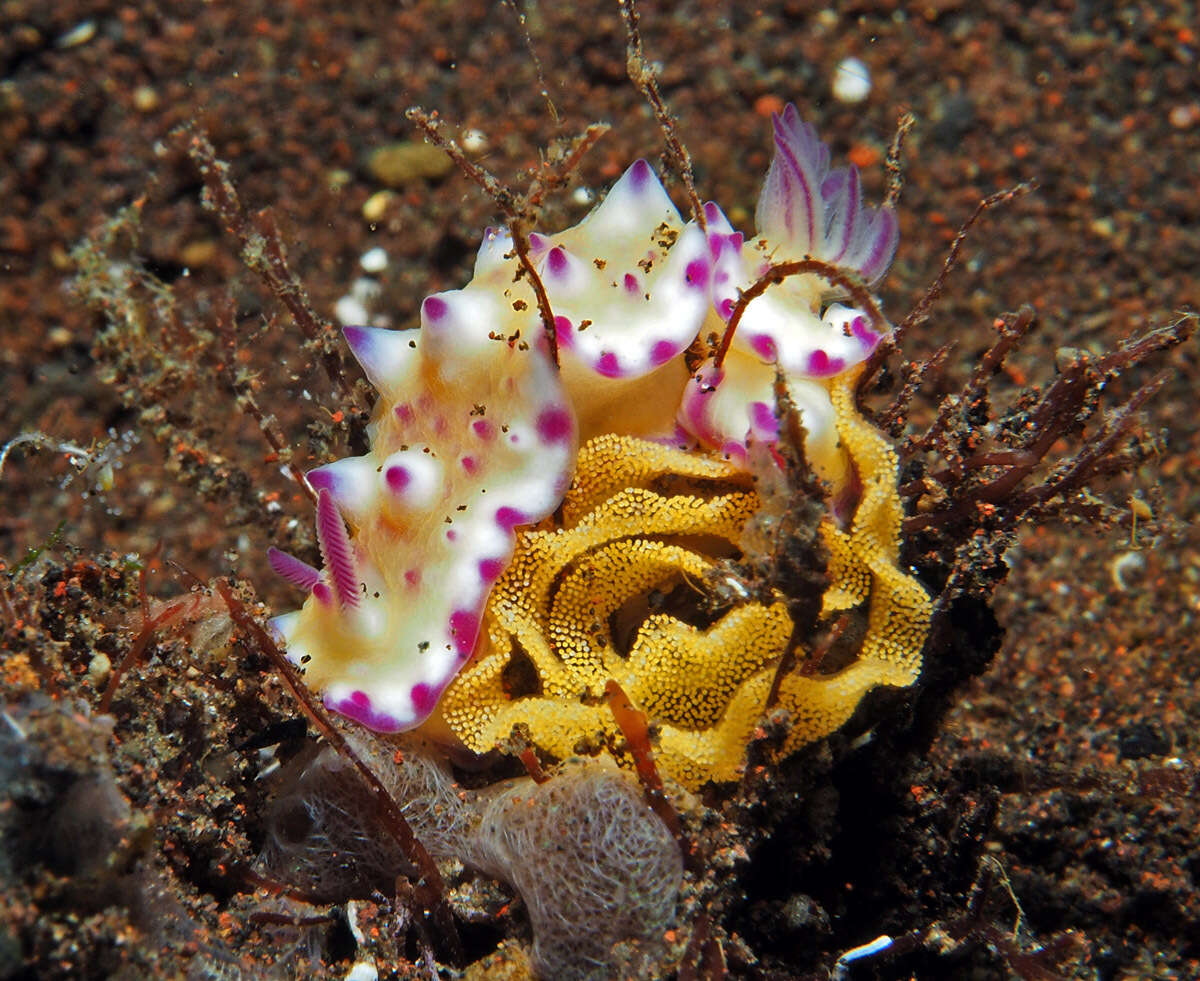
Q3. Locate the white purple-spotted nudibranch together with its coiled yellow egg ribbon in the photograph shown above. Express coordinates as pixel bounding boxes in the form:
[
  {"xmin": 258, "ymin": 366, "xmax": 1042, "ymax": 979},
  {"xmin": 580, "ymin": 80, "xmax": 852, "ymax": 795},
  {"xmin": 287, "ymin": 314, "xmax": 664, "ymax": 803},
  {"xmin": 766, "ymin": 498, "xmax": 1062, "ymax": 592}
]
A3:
[{"xmin": 270, "ymin": 107, "xmax": 929, "ymax": 787}]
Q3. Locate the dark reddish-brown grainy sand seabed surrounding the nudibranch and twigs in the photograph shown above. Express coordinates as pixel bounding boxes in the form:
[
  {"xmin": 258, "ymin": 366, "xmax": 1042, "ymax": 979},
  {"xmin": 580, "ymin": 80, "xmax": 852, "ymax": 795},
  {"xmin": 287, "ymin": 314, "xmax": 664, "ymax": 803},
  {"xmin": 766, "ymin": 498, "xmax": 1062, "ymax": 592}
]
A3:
[{"xmin": 0, "ymin": 0, "xmax": 1200, "ymax": 979}]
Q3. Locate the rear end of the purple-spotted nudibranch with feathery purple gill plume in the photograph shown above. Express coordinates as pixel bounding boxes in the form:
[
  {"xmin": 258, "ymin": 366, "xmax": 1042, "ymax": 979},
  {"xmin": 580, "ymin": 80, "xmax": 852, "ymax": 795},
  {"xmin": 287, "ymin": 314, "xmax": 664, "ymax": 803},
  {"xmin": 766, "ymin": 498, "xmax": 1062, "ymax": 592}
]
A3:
[{"xmin": 680, "ymin": 106, "xmax": 899, "ymax": 481}]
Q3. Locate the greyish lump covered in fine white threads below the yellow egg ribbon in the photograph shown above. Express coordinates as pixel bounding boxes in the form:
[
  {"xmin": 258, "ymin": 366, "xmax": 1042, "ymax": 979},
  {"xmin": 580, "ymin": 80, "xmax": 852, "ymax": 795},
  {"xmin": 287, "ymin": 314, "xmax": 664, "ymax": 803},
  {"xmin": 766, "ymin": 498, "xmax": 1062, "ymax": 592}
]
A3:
[{"xmin": 260, "ymin": 730, "xmax": 683, "ymax": 981}]
